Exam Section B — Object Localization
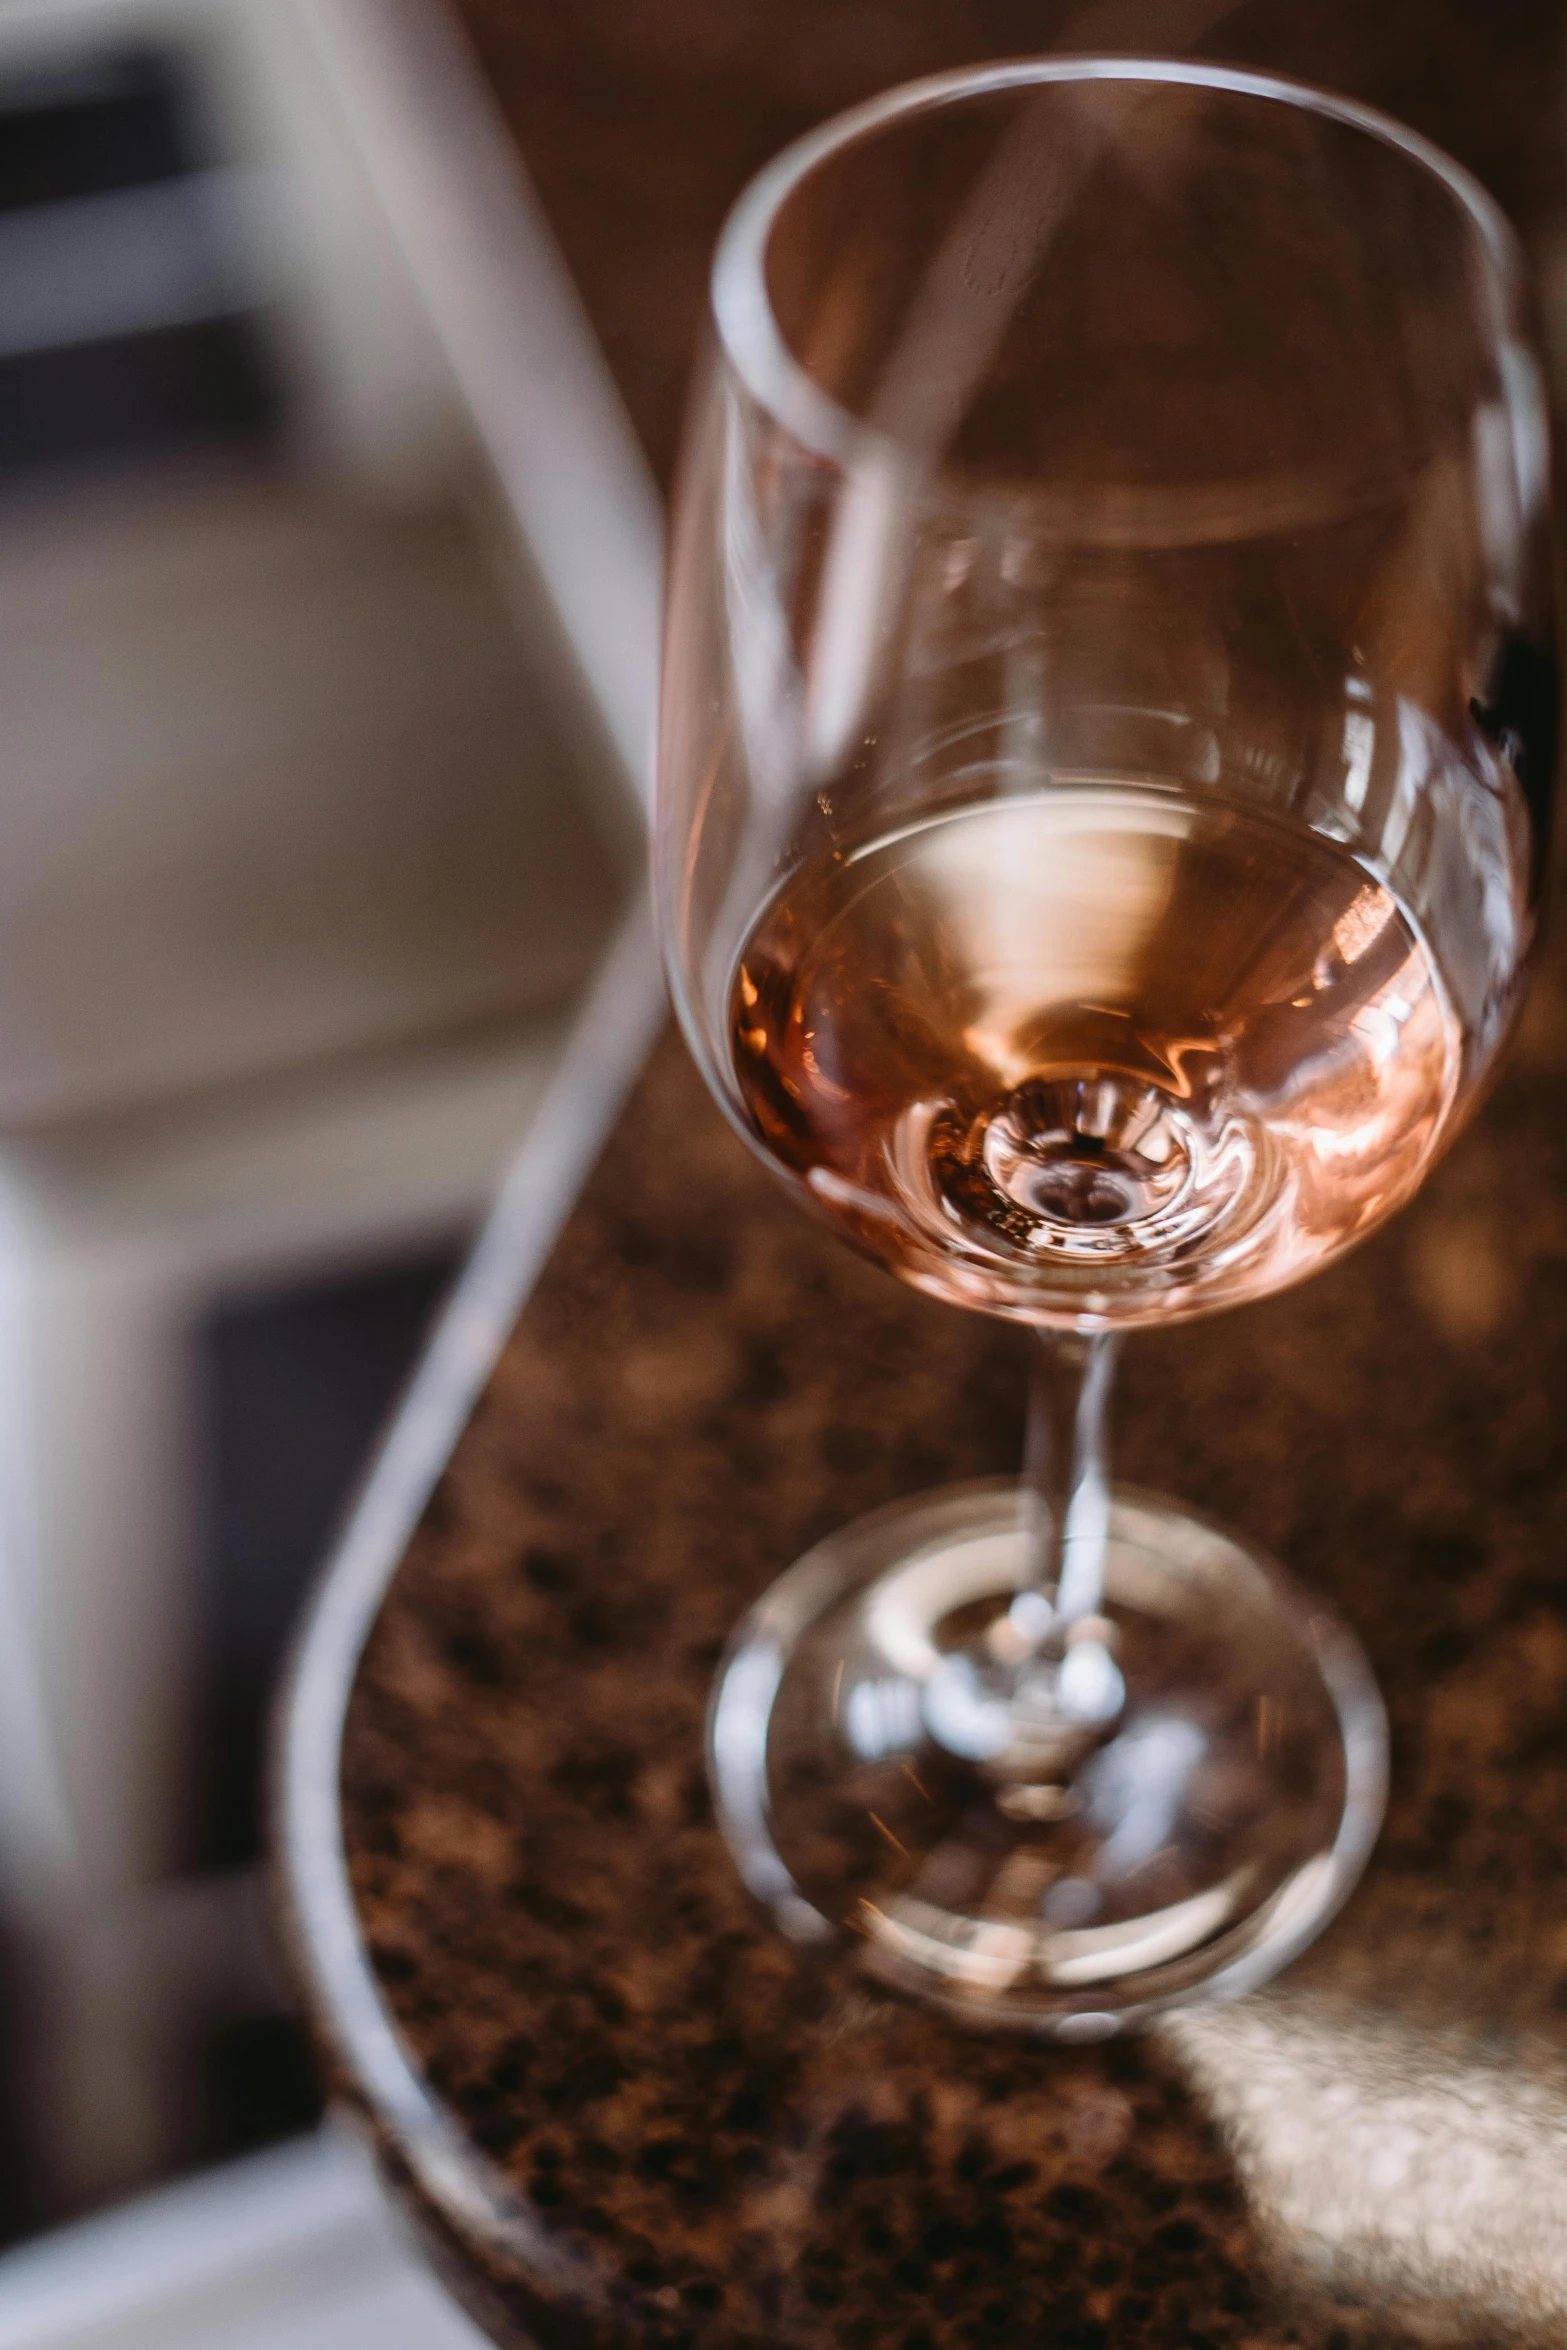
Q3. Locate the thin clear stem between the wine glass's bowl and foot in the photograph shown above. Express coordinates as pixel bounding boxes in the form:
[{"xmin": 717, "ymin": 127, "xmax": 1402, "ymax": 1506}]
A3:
[{"xmin": 1013, "ymin": 1330, "xmax": 1118, "ymax": 1636}]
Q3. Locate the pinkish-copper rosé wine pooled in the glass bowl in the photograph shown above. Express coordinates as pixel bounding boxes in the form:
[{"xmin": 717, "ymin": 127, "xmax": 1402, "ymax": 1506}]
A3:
[{"xmin": 731, "ymin": 783, "xmax": 1461, "ymax": 1328}]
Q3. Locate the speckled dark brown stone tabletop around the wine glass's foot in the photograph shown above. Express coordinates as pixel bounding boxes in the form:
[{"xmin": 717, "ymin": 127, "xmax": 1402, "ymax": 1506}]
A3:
[{"xmin": 314, "ymin": 944, "xmax": 1567, "ymax": 2350}]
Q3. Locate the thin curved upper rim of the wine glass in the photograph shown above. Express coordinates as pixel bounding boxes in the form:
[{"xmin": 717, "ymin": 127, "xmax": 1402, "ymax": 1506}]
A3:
[{"xmin": 709, "ymin": 54, "xmax": 1525, "ymax": 463}]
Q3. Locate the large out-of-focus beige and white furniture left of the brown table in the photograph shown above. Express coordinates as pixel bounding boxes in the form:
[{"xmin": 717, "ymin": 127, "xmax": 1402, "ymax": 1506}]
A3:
[{"xmin": 0, "ymin": 0, "xmax": 660, "ymax": 2209}]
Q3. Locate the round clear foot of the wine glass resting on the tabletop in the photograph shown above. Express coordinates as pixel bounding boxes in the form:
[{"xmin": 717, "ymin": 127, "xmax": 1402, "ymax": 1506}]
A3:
[{"xmin": 709, "ymin": 1481, "xmax": 1386, "ymax": 2040}]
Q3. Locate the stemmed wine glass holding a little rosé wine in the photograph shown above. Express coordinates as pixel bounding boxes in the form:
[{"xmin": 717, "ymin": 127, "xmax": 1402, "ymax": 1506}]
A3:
[{"xmin": 655, "ymin": 59, "xmax": 1555, "ymax": 2040}]
